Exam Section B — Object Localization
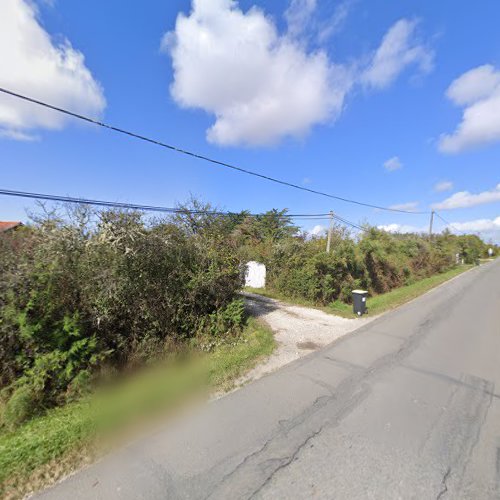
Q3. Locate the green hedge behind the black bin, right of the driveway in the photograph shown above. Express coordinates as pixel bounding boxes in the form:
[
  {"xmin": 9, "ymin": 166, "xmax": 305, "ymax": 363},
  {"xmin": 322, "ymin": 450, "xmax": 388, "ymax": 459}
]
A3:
[{"xmin": 259, "ymin": 227, "xmax": 489, "ymax": 305}]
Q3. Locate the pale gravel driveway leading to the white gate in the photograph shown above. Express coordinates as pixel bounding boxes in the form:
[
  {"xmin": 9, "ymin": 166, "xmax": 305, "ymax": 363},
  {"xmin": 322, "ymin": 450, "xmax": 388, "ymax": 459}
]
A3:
[{"xmin": 242, "ymin": 292, "xmax": 375, "ymax": 382}]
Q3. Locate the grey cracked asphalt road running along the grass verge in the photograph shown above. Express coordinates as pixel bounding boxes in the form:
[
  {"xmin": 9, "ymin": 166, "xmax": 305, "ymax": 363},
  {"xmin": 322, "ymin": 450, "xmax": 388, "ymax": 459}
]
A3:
[{"xmin": 40, "ymin": 261, "xmax": 500, "ymax": 500}]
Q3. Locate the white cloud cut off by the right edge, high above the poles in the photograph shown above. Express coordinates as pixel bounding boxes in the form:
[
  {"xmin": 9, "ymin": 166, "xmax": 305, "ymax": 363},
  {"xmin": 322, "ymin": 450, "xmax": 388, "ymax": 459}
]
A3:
[{"xmin": 439, "ymin": 64, "xmax": 500, "ymax": 153}]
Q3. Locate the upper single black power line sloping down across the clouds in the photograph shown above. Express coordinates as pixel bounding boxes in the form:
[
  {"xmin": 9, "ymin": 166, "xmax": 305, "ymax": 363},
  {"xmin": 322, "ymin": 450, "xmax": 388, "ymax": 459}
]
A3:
[{"xmin": 0, "ymin": 87, "xmax": 428, "ymax": 215}]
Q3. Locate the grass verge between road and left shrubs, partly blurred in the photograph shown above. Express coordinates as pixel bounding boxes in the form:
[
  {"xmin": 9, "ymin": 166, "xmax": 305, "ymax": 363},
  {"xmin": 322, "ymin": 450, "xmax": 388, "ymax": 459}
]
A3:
[{"xmin": 0, "ymin": 318, "xmax": 275, "ymax": 498}]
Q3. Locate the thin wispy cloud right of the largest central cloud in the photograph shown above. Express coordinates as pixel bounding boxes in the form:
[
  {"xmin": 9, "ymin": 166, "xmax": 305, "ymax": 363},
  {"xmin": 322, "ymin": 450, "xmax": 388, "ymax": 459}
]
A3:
[{"xmin": 362, "ymin": 19, "xmax": 434, "ymax": 89}]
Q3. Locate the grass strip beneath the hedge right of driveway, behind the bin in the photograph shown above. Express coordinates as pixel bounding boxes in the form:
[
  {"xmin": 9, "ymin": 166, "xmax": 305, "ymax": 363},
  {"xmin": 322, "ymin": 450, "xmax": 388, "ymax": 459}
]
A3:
[{"xmin": 245, "ymin": 265, "xmax": 473, "ymax": 318}]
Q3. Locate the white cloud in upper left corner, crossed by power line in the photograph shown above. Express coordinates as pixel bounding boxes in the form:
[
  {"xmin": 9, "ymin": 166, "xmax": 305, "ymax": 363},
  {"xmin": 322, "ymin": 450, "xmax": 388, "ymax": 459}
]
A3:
[{"xmin": 0, "ymin": 0, "xmax": 106, "ymax": 140}]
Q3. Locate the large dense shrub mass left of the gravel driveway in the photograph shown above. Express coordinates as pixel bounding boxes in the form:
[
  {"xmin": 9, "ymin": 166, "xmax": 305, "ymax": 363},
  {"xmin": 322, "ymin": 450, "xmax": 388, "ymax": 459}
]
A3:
[{"xmin": 0, "ymin": 205, "xmax": 243, "ymax": 424}]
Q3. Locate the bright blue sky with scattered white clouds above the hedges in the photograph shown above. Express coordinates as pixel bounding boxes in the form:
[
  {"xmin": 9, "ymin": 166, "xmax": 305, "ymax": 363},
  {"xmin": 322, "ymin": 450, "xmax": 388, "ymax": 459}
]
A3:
[{"xmin": 0, "ymin": 0, "xmax": 500, "ymax": 241}]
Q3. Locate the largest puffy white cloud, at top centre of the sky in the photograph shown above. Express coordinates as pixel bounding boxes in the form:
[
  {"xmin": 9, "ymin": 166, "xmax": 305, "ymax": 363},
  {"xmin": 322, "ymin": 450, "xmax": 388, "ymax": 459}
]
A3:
[{"xmin": 162, "ymin": 0, "xmax": 353, "ymax": 145}]
